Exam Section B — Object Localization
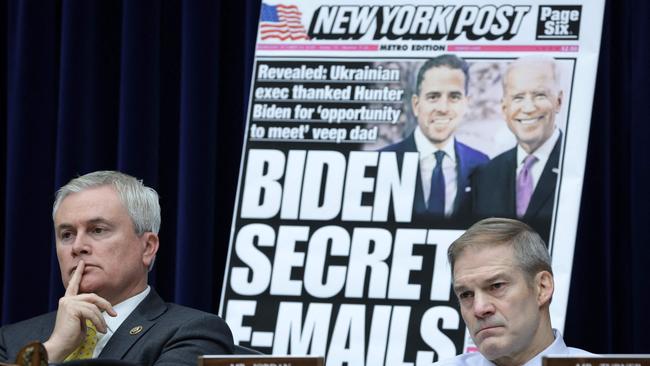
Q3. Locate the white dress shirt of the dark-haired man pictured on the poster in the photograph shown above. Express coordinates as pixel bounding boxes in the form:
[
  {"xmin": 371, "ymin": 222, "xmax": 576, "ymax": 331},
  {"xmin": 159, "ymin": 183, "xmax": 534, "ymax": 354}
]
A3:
[{"xmin": 413, "ymin": 127, "xmax": 458, "ymax": 216}]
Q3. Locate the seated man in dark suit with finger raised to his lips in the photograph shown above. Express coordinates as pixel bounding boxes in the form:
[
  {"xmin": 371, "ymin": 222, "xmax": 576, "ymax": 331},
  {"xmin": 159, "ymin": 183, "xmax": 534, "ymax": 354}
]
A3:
[{"xmin": 0, "ymin": 171, "xmax": 234, "ymax": 365}]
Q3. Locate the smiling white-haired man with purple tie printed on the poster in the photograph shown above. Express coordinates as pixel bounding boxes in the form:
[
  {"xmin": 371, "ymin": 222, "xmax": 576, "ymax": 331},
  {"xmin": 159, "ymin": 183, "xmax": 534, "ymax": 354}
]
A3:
[{"xmin": 472, "ymin": 56, "xmax": 563, "ymax": 241}]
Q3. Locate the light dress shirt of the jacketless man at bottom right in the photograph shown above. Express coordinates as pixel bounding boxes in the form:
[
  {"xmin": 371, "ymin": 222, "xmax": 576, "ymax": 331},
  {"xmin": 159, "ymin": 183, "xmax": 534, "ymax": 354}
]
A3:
[{"xmin": 435, "ymin": 329, "xmax": 596, "ymax": 366}]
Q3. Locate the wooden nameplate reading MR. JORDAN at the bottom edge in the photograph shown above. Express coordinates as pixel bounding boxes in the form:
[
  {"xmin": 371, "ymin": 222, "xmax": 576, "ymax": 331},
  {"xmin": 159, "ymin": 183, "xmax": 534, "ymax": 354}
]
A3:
[{"xmin": 199, "ymin": 355, "xmax": 325, "ymax": 366}]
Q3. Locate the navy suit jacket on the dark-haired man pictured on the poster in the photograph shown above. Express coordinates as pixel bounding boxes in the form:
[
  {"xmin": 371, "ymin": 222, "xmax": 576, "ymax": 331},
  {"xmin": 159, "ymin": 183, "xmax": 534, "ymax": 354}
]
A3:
[{"xmin": 381, "ymin": 133, "xmax": 490, "ymax": 222}]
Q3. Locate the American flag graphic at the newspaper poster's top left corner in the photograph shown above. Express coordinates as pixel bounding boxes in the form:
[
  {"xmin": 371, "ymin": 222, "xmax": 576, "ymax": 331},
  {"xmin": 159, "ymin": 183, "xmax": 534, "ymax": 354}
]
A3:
[{"xmin": 260, "ymin": 3, "xmax": 309, "ymax": 41}]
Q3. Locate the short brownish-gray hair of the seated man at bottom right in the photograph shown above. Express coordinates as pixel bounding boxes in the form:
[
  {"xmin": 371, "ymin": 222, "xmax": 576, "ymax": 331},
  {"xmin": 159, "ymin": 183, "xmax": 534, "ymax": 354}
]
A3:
[{"xmin": 447, "ymin": 218, "xmax": 553, "ymax": 280}]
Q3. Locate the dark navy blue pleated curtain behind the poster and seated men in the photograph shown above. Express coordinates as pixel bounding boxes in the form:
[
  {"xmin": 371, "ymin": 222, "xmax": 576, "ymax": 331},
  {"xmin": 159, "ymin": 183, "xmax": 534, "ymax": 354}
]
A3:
[{"xmin": 0, "ymin": 0, "xmax": 650, "ymax": 353}]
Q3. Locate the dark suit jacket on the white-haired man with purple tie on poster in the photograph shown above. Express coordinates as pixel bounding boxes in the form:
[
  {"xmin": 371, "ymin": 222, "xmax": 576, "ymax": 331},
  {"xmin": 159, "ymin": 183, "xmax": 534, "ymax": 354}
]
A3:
[{"xmin": 472, "ymin": 134, "xmax": 562, "ymax": 243}]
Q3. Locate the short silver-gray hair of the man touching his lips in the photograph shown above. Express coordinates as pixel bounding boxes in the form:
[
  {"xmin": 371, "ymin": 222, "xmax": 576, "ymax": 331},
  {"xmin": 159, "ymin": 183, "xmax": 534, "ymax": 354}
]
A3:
[{"xmin": 52, "ymin": 170, "xmax": 160, "ymax": 235}]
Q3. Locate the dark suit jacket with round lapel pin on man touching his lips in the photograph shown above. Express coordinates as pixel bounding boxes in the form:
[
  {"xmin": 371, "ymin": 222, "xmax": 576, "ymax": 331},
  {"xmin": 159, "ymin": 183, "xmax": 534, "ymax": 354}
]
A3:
[{"xmin": 0, "ymin": 288, "xmax": 234, "ymax": 366}]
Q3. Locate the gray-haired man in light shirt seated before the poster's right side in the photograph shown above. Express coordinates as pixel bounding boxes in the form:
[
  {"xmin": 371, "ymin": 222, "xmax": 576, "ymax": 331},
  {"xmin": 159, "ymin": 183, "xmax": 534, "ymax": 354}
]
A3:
[{"xmin": 439, "ymin": 218, "xmax": 591, "ymax": 366}]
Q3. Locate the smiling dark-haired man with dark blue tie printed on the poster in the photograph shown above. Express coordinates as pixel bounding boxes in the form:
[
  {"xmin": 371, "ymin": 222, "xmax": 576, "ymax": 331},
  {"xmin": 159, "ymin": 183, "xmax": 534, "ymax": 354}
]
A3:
[{"xmin": 382, "ymin": 54, "xmax": 488, "ymax": 220}]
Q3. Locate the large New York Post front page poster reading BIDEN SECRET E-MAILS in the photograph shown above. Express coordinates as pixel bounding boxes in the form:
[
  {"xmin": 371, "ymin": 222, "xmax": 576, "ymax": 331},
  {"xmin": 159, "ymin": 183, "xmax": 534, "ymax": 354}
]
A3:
[{"xmin": 220, "ymin": 0, "xmax": 604, "ymax": 366}]
